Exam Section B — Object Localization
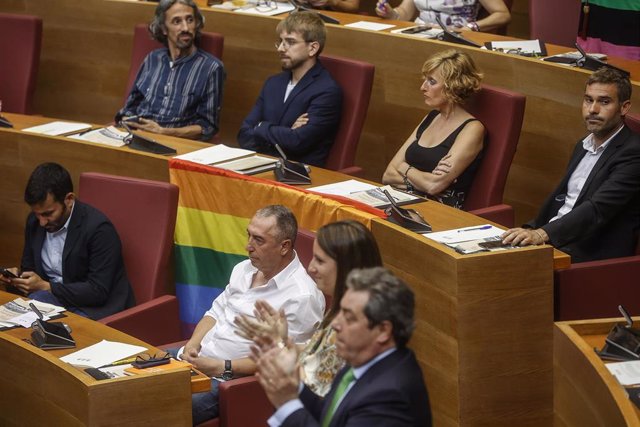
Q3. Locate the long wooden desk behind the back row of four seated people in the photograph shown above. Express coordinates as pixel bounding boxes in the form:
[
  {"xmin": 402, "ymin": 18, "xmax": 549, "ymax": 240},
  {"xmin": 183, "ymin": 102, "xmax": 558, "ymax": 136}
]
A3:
[{"xmin": 0, "ymin": 0, "xmax": 640, "ymax": 227}]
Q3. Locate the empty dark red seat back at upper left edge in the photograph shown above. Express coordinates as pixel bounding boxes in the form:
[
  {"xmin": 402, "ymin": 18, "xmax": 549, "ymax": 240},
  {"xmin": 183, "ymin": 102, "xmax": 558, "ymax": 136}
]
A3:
[{"xmin": 0, "ymin": 13, "xmax": 42, "ymax": 114}]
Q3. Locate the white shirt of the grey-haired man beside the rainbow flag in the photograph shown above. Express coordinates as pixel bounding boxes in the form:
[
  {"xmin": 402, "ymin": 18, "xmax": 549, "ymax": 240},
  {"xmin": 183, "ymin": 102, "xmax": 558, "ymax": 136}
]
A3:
[{"xmin": 200, "ymin": 254, "xmax": 324, "ymax": 360}]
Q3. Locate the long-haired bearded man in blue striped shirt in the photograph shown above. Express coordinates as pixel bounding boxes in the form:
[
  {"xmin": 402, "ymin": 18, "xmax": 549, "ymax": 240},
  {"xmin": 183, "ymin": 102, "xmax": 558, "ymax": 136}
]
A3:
[{"xmin": 115, "ymin": 0, "xmax": 224, "ymax": 141}]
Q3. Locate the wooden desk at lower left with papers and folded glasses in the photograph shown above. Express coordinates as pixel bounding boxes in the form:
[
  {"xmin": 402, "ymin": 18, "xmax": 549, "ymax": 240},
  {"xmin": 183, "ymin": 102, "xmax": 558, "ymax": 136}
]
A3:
[{"xmin": 0, "ymin": 292, "xmax": 191, "ymax": 426}]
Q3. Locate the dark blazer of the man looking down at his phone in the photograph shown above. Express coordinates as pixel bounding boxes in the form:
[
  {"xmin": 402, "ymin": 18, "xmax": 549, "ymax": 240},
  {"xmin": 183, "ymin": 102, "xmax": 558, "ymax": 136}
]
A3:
[{"xmin": 21, "ymin": 200, "xmax": 135, "ymax": 319}]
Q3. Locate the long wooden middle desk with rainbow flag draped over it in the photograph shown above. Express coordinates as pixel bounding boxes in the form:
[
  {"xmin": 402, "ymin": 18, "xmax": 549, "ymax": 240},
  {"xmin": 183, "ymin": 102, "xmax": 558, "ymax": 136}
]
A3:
[{"xmin": 0, "ymin": 115, "xmax": 554, "ymax": 426}]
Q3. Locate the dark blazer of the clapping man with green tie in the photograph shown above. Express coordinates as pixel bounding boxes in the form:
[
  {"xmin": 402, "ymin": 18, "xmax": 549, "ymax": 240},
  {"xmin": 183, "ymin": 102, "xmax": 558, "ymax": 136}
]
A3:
[{"xmin": 283, "ymin": 349, "xmax": 431, "ymax": 427}]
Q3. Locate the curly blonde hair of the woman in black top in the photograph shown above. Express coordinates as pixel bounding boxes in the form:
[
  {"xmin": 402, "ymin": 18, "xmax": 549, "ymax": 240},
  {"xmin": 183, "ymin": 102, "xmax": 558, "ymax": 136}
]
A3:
[{"xmin": 422, "ymin": 49, "xmax": 482, "ymax": 104}]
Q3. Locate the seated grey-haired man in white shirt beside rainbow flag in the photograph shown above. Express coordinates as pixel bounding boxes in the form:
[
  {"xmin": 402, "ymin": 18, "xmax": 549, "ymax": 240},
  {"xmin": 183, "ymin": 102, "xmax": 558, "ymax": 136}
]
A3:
[{"xmin": 178, "ymin": 205, "xmax": 324, "ymax": 425}]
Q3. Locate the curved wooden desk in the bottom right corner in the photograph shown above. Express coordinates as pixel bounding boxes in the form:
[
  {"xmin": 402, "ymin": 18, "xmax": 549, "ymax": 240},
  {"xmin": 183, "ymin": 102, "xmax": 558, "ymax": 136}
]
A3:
[{"xmin": 553, "ymin": 319, "xmax": 640, "ymax": 427}]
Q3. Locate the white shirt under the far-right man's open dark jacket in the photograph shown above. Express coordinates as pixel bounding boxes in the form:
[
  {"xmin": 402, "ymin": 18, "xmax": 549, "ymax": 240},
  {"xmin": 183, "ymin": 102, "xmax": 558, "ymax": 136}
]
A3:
[{"xmin": 549, "ymin": 125, "xmax": 624, "ymax": 222}]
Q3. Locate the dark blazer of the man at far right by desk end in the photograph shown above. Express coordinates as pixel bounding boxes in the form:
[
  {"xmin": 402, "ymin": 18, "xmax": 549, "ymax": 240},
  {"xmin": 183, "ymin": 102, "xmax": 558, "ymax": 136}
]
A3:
[{"xmin": 526, "ymin": 126, "xmax": 640, "ymax": 262}]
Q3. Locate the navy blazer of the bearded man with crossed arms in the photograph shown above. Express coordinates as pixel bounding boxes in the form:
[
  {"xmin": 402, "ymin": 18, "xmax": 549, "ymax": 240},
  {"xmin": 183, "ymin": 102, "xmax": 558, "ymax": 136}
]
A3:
[{"xmin": 238, "ymin": 61, "xmax": 342, "ymax": 166}]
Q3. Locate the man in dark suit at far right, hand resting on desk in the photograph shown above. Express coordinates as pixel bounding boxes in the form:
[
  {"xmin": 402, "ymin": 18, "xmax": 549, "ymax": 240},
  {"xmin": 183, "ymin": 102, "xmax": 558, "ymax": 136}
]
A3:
[{"xmin": 502, "ymin": 68, "xmax": 640, "ymax": 262}]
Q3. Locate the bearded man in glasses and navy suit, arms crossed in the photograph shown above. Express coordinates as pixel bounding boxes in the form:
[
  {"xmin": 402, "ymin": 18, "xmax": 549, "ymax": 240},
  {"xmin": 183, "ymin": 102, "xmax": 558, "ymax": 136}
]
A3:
[{"xmin": 238, "ymin": 12, "xmax": 342, "ymax": 166}]
